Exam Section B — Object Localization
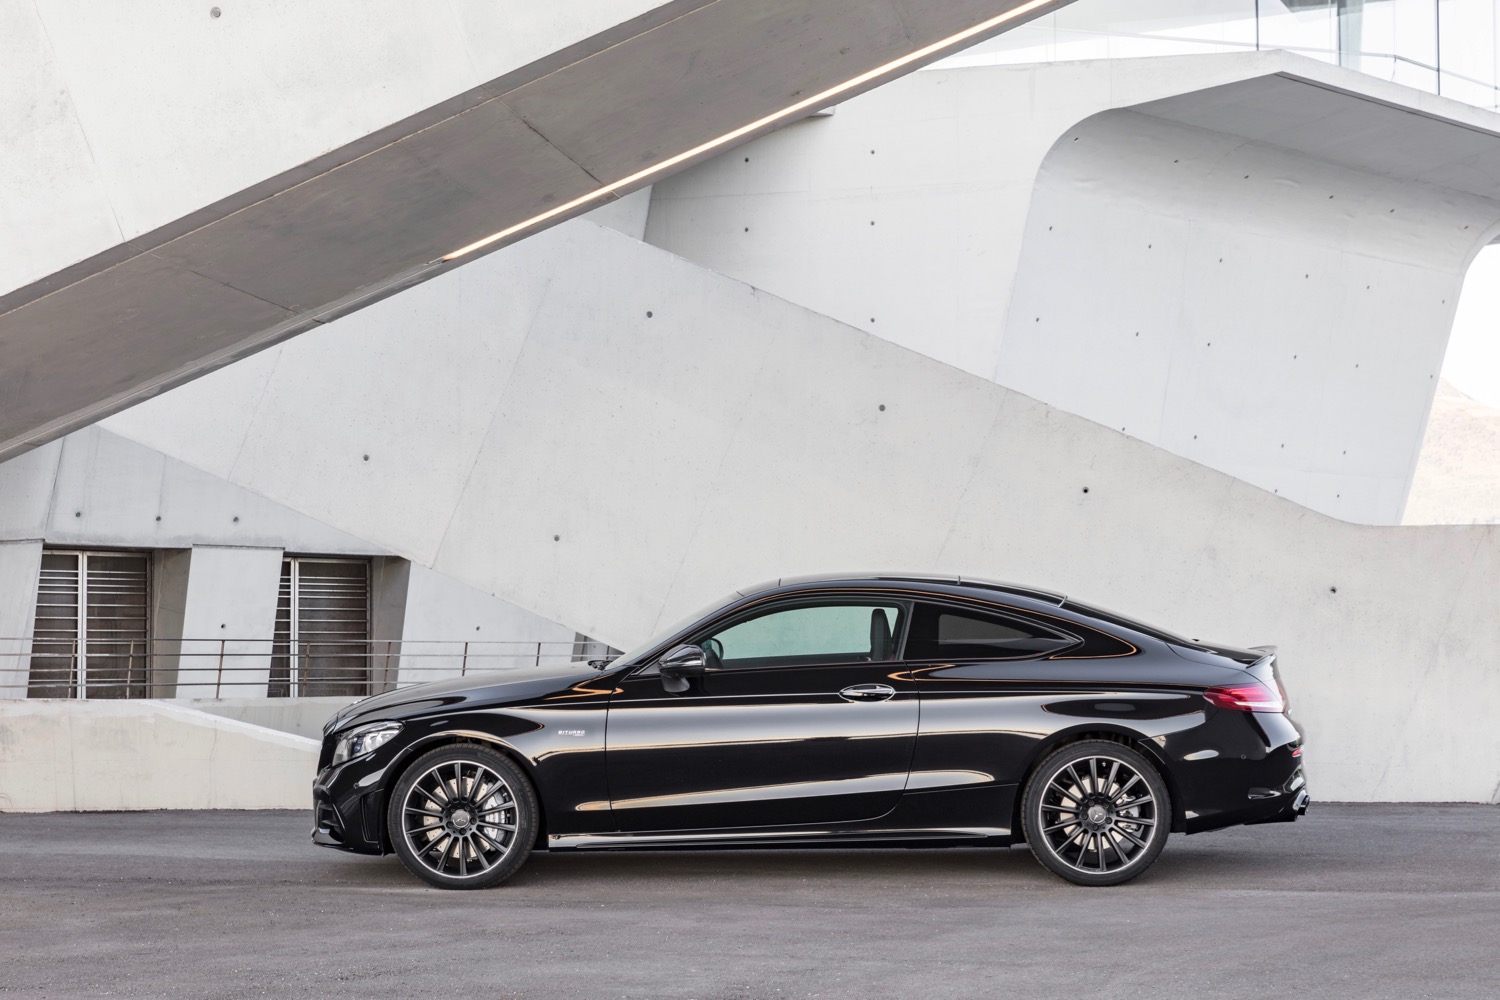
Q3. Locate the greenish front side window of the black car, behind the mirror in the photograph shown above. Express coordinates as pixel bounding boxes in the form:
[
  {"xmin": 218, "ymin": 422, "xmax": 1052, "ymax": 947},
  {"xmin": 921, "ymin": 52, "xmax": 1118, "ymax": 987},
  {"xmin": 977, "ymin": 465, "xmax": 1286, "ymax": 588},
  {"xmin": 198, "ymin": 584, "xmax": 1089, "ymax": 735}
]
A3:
[{"xmin": 699, "ymin": 604, "xmax": 902, "ymax": 669}]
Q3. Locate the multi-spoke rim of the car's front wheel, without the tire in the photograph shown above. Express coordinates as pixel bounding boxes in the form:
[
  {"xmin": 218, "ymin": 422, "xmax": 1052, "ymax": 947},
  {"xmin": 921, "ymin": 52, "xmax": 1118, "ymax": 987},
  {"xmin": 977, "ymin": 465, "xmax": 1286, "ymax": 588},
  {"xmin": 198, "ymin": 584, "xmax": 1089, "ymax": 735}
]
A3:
[{"xmin": 401, "ymin": 760, "xmax": 519, "ymax": 879}]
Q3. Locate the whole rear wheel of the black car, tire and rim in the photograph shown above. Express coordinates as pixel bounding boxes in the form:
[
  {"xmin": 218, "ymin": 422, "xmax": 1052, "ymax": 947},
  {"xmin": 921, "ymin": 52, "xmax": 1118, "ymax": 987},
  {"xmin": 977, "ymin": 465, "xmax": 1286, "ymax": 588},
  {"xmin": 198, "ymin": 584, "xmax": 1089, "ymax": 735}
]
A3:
[{"xmin": 1022, "ymin": 739, "xmax": 1172, "ymax": 886}]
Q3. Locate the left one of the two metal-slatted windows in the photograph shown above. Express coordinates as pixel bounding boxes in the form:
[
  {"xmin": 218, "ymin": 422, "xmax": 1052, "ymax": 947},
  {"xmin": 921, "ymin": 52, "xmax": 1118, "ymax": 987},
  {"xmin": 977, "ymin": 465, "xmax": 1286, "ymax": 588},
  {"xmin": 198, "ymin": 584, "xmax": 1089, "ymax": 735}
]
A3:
[{"xmin": 27, "ymin": 549, "xmax": 152, "ymax": 699}]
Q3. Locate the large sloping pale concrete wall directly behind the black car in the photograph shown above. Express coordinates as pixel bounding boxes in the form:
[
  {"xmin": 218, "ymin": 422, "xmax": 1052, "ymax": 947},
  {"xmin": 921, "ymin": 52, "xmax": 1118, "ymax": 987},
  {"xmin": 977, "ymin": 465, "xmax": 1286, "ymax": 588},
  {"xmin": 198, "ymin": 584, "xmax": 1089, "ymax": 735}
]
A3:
[{"xmin": 110, "ymin": 222, "xmax": 1500, "ymax": 801}]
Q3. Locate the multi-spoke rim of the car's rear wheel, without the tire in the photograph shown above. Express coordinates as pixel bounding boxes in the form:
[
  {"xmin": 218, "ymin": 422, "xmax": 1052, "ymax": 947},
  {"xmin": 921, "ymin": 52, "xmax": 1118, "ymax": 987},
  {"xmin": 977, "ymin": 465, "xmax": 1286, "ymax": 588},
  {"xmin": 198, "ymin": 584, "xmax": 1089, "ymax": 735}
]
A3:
[{"xmin": 1037, "ymin": 754, "xmax": 1160, "ymax": 876}]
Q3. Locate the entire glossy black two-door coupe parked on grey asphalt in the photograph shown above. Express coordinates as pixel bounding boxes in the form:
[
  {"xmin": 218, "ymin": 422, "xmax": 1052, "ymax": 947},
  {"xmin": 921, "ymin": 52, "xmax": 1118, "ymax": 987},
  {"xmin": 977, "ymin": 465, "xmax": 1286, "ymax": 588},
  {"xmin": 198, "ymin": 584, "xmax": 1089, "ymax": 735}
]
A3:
[{"xmin": 312, "ymin": 576, "xmax": 1308, "ymax": 889}]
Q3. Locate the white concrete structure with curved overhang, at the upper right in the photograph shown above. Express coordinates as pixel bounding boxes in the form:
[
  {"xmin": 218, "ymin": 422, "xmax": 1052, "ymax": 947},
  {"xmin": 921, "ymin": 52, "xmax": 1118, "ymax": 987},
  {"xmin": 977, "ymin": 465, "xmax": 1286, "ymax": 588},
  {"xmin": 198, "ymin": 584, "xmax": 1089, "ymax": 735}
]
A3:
[{"xmin": 647, "ymin": 50, "xmax": 1500, "ymax": 525}]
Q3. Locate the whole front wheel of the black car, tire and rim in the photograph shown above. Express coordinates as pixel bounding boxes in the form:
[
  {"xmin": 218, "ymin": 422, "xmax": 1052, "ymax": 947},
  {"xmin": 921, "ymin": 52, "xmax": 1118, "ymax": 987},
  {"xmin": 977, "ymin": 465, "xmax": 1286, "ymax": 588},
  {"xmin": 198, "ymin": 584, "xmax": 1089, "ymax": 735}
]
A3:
[{"xmin": 386, "ymin": 744, "xmax": 539, "ymax": 889}]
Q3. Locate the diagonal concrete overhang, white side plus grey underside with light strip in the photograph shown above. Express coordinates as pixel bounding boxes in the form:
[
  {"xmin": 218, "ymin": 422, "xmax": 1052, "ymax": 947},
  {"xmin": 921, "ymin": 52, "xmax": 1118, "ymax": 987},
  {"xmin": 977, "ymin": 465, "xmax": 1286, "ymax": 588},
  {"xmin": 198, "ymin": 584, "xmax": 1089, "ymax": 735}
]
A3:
[{"xmin": 0, "ymin": 0, "xmax": 1068, "ymax": 459}]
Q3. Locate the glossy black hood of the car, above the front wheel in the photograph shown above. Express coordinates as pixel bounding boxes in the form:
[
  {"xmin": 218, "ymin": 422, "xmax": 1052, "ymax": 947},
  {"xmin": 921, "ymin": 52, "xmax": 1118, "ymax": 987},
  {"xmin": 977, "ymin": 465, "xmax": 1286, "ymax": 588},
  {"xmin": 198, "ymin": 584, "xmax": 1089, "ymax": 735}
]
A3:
[{"xmin": 323, "ymin": 663, "xmax": 599, "ymax": 733}]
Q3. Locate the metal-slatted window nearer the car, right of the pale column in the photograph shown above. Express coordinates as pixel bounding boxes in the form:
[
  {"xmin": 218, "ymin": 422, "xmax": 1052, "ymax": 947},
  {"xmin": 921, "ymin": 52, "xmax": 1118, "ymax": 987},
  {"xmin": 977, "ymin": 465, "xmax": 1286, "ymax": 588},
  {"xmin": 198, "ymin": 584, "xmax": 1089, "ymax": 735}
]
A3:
[{"xmin": 269, "ymin": 556, "xmax": 371, "ymax": 697}]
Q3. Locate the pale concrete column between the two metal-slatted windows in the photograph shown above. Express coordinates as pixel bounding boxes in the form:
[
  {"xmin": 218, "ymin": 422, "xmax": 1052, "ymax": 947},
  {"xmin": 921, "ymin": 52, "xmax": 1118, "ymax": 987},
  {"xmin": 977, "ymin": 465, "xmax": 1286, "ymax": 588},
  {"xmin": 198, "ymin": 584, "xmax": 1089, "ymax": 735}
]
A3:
[{"xmin": 176, "ymin": 546, "xmax": 282, "ymax": 697}]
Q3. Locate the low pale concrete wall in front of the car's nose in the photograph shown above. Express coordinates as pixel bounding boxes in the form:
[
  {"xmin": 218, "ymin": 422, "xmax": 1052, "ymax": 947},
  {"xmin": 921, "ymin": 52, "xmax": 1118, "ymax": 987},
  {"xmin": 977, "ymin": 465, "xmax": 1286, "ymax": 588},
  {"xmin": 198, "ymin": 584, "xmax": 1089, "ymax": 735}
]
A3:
[{"xmin": 0, "ymin": 700, "xmax": 318, "ymax": 813}]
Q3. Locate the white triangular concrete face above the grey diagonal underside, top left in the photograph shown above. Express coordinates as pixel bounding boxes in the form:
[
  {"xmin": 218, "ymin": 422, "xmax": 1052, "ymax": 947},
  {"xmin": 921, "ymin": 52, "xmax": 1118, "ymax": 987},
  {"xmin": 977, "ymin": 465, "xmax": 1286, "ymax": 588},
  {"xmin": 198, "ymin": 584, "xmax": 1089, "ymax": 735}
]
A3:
[{"xmin": 0, "ymin": 0, "xmax": 659, "ymax": 291}]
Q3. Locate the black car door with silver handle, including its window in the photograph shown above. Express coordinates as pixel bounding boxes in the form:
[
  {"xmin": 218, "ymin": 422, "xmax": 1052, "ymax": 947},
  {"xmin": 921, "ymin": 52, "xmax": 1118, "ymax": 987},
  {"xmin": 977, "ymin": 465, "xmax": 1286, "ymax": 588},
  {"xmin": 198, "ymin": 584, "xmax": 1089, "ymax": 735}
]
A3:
[{"xmin": 606, "ymin": 597, "xmax": 917, "ymax": 832}]
